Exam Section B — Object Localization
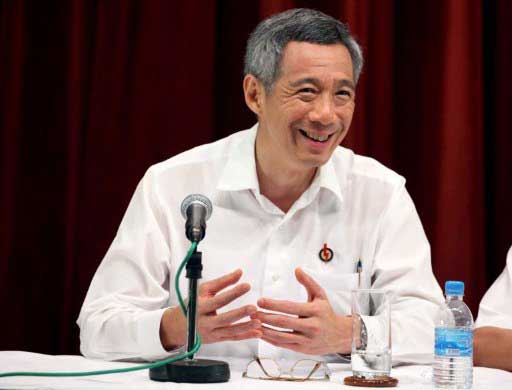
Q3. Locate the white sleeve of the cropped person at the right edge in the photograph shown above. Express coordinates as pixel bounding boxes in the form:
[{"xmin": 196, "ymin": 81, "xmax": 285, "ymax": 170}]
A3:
[{"xmin": 475, "ymin": 247, "xmax": 512, "ymax": 329}]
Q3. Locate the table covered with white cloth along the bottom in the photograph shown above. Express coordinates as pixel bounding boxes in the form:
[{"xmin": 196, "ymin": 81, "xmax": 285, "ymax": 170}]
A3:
[{"xmin": 0, "ymin": 351, "xmax": 512, "ymax": 390}]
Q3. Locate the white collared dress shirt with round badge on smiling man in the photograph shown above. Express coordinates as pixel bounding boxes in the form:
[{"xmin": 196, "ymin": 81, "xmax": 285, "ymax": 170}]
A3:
[{"xmin": 77, "ymin": 125, "xmax": 443, "ymax": 363}]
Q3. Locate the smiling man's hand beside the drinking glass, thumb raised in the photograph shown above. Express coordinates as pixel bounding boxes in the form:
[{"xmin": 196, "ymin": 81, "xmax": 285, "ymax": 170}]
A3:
[{"xmin": 251, "ymin": 268, "xmax": 352, "ymax": 355}]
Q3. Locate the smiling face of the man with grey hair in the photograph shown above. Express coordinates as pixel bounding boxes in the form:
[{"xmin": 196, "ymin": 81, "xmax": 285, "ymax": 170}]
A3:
[{"xmin": 259, "ymin": 42, "xmax": 355, "ymax": 170}]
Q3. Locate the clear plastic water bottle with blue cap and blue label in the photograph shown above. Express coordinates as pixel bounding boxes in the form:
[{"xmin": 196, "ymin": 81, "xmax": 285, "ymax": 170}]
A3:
[{"xmin": 433, "ymin": 281, "xmax": 473, "ymax": 389}]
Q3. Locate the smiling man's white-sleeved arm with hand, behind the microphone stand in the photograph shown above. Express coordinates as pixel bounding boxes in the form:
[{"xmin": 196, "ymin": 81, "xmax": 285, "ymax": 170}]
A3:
[{"xmin": 77, "ymin": 170, "xmax": 261, "ymax": 360}]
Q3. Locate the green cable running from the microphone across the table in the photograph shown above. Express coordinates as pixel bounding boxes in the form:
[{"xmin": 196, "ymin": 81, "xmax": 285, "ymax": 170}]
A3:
[{"xmin": 0, "ymin": 242, "xmax": 201, "ymax": 378}]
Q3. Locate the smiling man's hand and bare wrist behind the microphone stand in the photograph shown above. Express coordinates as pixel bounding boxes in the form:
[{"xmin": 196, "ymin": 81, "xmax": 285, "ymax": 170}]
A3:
[{"xmin": 160, "ymin": 270, "xmax": 262, "ymax": 350}]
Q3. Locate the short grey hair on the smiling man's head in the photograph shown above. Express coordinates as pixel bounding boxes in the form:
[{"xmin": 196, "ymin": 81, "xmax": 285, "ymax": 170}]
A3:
[{"xmin": 244, "ymin": 8, "xmax": 363, "ymax": 92}]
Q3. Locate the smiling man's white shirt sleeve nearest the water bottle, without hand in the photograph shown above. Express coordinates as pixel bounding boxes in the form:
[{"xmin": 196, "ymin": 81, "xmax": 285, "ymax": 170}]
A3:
[{"xmin": 372, "ymin": 182, "xmax": 444, "ymax": 364}]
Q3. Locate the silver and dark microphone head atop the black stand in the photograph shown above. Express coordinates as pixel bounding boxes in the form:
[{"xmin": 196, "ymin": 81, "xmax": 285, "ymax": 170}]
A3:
[{"xmin": 181, "ymin": 194, "xmax": 212, "ymax": 243}]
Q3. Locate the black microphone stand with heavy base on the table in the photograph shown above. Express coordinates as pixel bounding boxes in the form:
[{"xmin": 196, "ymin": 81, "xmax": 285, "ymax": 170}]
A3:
[{"xmin": 149, "ymin": 250, "xmax": 230, "ymax": 383}]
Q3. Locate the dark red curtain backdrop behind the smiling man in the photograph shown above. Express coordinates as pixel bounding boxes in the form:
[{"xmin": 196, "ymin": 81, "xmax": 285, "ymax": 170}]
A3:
[{"xmin": 0, "ymin": 0, "xmax": 512, "ymax": 354}]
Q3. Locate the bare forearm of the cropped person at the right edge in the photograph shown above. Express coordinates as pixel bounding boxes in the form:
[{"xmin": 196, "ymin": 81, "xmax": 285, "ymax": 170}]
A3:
[{"xmin": 473, "ymin": 326, "xmax": 512, "ymax": 371}]
